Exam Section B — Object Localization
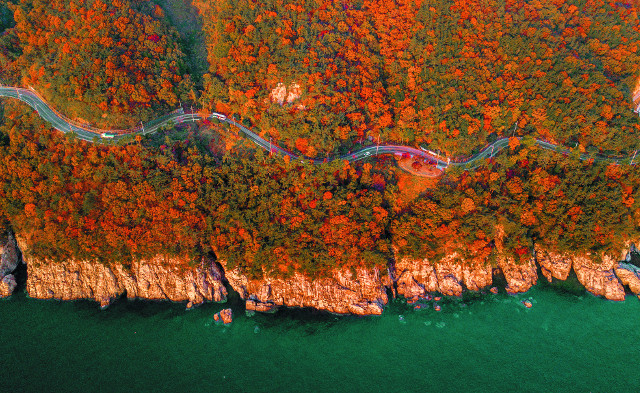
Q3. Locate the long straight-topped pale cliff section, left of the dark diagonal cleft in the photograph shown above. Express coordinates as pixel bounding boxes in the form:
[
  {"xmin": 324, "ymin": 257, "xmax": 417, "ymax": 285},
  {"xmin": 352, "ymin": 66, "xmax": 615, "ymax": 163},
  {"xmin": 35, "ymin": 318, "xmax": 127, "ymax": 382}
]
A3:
[{"xmin": 26, "ymin": 257, "xmax": 227, "ymax": 307}]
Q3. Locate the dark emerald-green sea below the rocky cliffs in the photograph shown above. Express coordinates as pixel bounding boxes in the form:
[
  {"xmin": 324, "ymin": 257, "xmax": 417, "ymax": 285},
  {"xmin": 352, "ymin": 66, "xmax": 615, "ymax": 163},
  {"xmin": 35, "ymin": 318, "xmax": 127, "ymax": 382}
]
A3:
[{"xmin": 0, "ymin": 278, "xmax": 640, "ymax": 392}]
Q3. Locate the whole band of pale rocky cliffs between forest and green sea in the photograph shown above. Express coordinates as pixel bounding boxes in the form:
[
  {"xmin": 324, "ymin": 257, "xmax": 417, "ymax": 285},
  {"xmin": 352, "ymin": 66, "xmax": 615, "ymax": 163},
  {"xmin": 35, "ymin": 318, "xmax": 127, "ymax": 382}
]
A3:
[{"xmin": 6, "ymin": 230, "xmax": 640, "ymax": 315}]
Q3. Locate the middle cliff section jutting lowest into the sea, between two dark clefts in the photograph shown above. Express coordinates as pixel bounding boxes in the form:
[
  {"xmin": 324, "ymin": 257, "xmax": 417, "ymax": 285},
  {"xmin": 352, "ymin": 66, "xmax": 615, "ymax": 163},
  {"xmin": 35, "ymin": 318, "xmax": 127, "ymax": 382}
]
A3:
[{"xmin": 221, "ymin": 261, "xmax": 388, "ymax": 315}]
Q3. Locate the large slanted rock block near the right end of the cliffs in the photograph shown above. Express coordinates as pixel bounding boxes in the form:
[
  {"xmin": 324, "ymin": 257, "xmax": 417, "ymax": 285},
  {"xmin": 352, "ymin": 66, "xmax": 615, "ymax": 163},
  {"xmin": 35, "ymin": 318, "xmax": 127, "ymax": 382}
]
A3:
[{"xmin": 573, "ymin": 255, "xmax": 624, "ymax": 301}]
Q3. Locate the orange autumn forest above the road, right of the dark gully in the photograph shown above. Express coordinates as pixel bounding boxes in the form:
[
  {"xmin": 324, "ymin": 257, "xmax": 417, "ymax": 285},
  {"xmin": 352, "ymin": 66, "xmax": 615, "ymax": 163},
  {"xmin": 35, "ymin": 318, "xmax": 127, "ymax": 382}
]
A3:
[{"xmin": 198, "ymin": 0, "xmax": 640, "ymax": 156}]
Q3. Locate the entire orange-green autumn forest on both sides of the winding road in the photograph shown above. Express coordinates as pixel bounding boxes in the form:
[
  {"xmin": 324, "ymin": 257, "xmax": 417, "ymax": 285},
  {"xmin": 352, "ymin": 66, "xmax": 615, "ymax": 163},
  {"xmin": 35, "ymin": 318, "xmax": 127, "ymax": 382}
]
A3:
[{"xmin": 0, "ymin": 0, "xmax": 640, "ymax": 276}]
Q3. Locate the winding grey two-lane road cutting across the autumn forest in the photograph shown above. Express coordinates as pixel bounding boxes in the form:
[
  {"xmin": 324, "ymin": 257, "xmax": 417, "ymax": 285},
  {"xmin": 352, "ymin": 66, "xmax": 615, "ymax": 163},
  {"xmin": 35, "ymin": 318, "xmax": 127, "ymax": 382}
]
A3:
[{"xmin": 0, "ymin": 86, "xmax": 636, "ymax": 169}]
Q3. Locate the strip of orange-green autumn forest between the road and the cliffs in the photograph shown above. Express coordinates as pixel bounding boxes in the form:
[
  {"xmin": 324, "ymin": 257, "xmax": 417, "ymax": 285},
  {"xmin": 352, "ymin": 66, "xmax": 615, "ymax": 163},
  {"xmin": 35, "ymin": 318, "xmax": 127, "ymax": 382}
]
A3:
[{"xmin": 0, "ymin": 97, "xmax": 640, "ymax": 276}]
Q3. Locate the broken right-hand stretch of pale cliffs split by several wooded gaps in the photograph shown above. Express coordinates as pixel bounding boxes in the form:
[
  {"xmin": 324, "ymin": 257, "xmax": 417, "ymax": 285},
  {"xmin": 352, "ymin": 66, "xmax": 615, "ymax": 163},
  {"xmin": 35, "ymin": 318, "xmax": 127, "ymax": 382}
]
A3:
[{"xmin": 391, "ymin": 244, "xmax": 640, "ymax": 301}]
